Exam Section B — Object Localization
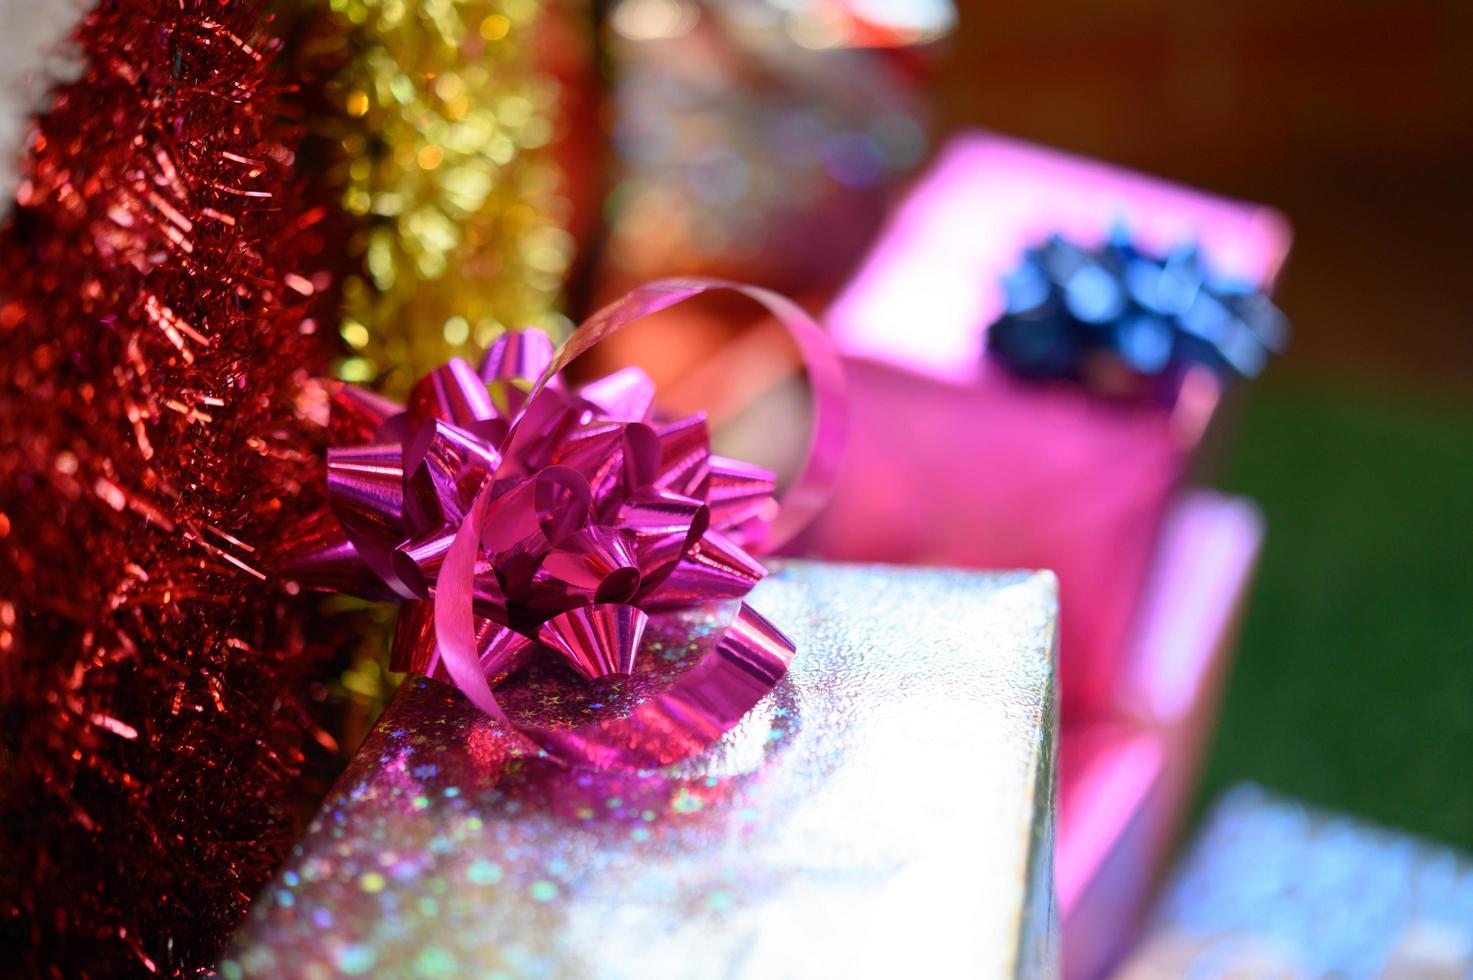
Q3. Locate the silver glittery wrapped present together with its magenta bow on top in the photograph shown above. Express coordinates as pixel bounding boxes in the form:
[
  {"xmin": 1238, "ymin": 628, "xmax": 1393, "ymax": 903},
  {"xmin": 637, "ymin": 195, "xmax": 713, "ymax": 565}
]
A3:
[{"xmin": 221, "ymin": 280, "xmax": 1056, "ymax": 976}]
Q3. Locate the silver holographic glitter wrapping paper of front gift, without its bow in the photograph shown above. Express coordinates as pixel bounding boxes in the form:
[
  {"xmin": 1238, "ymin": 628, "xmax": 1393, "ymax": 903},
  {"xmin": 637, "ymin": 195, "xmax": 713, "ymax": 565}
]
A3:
[{"xmin": 219, "ymin": 561, "xmax": 1056, "ymax": 977}]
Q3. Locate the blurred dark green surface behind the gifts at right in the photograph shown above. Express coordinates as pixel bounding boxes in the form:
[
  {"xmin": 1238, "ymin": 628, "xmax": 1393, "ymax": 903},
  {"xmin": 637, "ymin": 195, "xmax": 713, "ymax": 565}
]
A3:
[{"xmin": 1198, "ymin": 382, "xmax": 1473, "ymax": 852}]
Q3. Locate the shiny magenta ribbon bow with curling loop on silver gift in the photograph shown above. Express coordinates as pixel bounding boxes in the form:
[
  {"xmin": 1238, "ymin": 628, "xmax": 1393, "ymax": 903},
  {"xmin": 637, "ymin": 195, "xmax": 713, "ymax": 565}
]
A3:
[{"xmin": 289, "ymin": 279, "xmax": 843, "ymax": 769}]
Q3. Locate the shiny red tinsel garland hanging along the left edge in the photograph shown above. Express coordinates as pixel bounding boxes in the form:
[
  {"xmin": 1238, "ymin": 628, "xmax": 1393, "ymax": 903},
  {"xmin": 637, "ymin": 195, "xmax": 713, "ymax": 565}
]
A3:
[{"xmin": 0, "ymin": 0, "xmax": 336, "ymax": 976}]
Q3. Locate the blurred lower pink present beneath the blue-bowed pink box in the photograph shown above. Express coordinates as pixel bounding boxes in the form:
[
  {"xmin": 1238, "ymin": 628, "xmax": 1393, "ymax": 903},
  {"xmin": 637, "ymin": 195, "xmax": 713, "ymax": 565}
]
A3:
[{"xmin": 1055, "ymin": 491, "xmax": 1262, "ymax": 980}]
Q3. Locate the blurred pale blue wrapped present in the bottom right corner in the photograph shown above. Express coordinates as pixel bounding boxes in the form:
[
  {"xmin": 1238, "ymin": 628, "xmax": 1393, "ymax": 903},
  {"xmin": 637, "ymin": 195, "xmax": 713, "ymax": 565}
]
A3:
[{"xmin": 1115, "ymin": 785, "xmax": 1473, "ymax": 980}]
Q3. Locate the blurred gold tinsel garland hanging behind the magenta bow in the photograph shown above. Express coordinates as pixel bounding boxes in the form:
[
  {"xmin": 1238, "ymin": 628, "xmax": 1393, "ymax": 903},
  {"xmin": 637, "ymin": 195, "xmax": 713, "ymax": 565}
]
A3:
[{"xmin": 328, "ymin": 0, "xmax": 573, "ymax": 395}]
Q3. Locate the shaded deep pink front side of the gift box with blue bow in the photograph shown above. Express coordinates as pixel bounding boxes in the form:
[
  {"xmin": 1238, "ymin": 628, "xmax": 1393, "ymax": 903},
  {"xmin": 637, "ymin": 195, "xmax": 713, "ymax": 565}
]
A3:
[{"xmin": 810, "ymin": 358, "xmax": 1186, "ymax": 716}]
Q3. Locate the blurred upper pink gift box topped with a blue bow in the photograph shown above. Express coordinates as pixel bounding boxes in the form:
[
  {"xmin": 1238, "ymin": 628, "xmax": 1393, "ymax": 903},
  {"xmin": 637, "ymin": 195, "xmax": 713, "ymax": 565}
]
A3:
[{"xmin": 809, "ymin": 134, "xmax": 1289, "ymax": 716}]
